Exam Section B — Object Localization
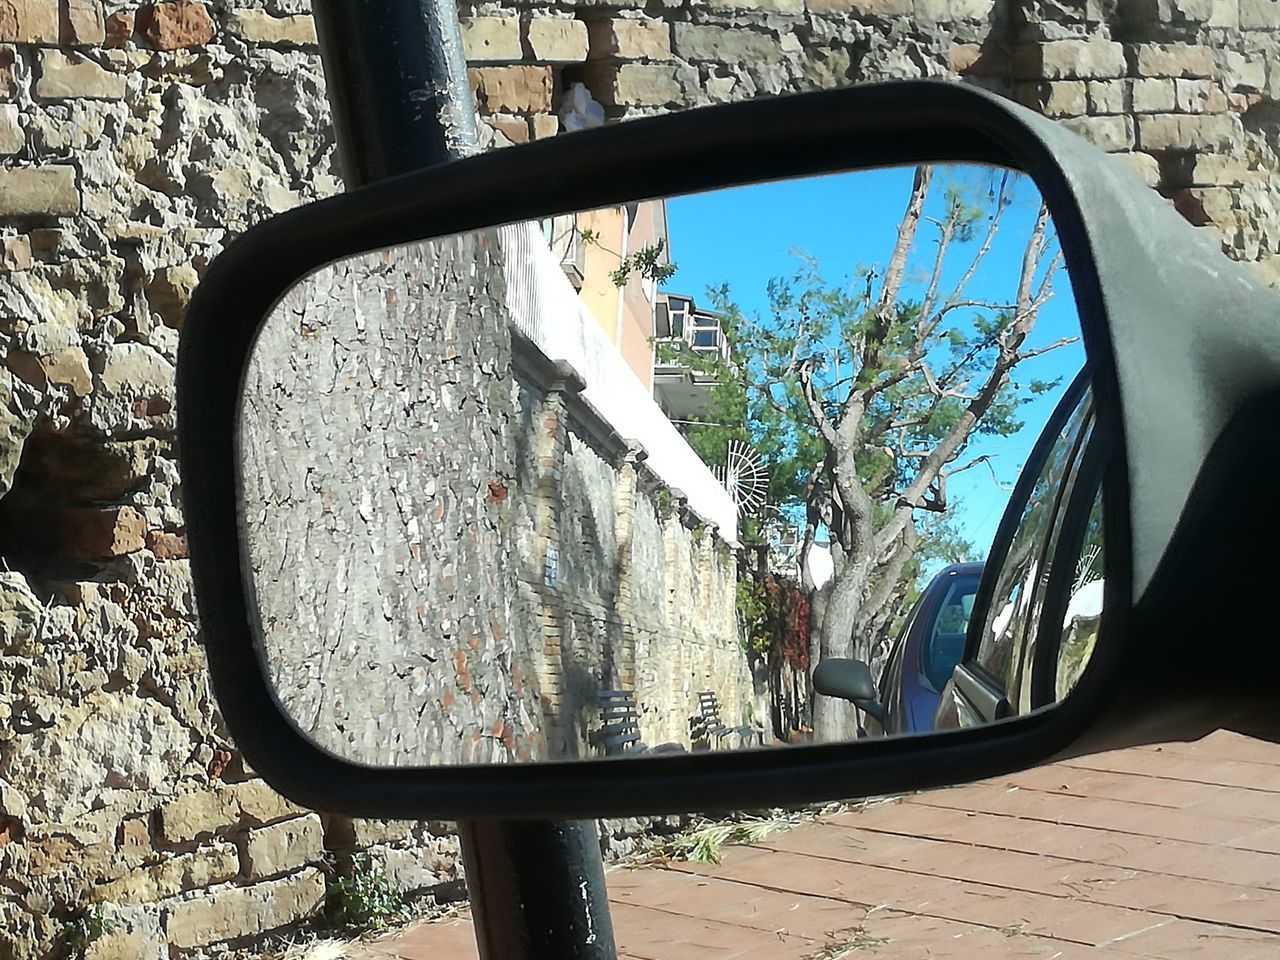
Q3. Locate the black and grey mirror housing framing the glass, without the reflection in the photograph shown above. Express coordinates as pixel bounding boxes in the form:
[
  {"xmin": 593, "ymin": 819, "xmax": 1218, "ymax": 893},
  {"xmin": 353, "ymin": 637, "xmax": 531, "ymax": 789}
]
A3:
[{"xmin": 178, "ymin": 81, "xmax": 1280, "ymax": 819}]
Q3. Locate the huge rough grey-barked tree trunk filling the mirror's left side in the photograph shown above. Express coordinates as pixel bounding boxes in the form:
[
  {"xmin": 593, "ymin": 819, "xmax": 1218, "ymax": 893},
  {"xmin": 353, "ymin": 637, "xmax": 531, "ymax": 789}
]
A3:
[{"xmin": 242, "ymin": 234, "xmax": 543, "ymax": 765}]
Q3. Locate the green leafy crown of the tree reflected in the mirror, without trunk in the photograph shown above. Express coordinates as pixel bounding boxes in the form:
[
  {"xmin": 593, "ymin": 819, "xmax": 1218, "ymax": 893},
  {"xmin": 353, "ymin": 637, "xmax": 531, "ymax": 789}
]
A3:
[{"xmin": 662, "ymin": 165, "xmax": 1059, "ymax": 647}]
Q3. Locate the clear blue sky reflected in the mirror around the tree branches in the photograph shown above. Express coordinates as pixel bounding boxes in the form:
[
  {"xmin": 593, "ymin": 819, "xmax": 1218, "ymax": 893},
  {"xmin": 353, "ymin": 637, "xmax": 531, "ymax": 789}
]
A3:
[{"xmin": 666, "ymin": 166, "xmax": 1084, "ymax": 557}]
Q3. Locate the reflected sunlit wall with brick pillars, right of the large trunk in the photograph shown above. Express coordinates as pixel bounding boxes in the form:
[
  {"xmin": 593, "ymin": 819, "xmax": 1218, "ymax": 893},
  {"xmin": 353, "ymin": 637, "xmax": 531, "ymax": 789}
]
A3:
[{"xmin": 506, "ymin": 353, "xmax": 750, "ymax": 756}]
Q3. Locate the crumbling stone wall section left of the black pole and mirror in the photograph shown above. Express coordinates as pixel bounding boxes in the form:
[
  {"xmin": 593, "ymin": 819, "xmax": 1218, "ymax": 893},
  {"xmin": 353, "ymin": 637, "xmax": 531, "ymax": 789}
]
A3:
[{"xmin": 0, "ymin": 0, "xmax": 339, "ymax": 959}]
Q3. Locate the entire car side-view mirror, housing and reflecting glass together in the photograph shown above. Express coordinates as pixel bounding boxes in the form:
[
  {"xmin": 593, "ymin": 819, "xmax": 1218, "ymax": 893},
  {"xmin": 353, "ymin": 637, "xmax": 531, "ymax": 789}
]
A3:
[{"xmin": 177, "ymin": 82, "xmax": 1280, "ymax": 819}]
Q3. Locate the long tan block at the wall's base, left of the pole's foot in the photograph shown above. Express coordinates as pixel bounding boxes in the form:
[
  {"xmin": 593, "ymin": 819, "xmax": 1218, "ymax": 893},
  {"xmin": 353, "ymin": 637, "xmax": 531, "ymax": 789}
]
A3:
[{"xmin": 165, "ymin": 869, "xmax": 325, "ymax": 950}]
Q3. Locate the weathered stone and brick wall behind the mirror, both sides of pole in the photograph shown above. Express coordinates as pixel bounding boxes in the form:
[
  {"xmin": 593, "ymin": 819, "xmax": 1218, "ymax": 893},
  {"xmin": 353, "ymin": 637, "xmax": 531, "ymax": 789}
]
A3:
[{"xmin": 0, "ymin": 0, "xmax": 1280, "ymax": 957}]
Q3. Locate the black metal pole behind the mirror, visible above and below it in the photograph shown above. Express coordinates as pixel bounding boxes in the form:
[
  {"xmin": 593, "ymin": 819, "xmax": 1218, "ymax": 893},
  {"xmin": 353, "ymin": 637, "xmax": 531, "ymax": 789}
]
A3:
[{"xmin": 304, "ymin": 0, "xmax": 616, "ymax": 960}]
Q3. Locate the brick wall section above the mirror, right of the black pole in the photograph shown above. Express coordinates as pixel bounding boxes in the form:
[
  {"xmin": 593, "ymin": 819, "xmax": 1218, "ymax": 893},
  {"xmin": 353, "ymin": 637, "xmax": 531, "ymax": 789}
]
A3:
[{"xmin": 463, "ymin": 0, "xmax": 1280, "ymax": 282}]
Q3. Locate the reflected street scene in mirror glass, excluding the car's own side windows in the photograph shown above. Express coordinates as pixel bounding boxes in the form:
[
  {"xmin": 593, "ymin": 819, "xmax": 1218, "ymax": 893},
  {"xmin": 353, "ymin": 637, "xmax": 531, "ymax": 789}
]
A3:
[{"xmin": 239, "ymin": 165, "xmax": 1096, "ymax": 765}]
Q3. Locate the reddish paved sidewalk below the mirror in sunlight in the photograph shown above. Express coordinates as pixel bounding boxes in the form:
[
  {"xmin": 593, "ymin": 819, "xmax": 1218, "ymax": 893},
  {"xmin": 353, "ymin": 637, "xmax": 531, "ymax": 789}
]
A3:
[{"xmin": 362, "ymin": 733, "xmax": 1280, "ymax": 960}]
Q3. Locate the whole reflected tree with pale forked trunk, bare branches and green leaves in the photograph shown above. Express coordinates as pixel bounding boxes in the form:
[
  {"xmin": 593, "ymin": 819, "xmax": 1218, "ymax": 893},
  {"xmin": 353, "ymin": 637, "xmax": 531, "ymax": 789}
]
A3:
[{"xmin": 678, "ymin": 166, "xmax": 1070, "ymax": 740}]
